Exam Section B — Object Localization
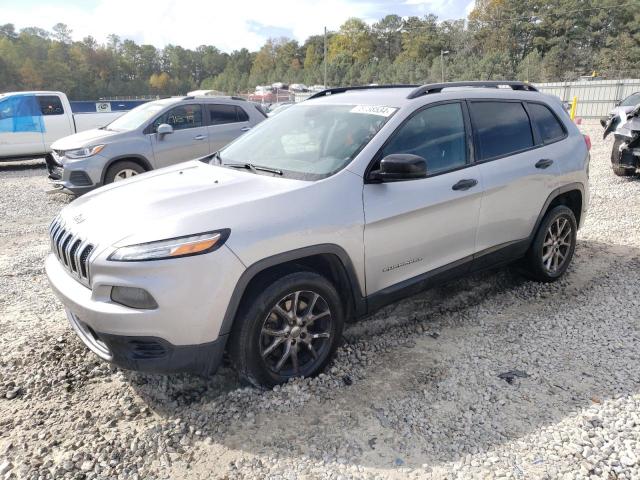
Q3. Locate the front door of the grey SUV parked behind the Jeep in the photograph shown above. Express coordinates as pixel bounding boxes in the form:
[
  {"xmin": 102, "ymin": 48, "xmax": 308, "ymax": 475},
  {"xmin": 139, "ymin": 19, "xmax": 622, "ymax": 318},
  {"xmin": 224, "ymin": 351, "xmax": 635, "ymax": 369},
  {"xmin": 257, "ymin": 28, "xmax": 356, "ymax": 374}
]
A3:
[{"xmin": 151, "ymin": 103, "xmax": 209, "ymax": 168}]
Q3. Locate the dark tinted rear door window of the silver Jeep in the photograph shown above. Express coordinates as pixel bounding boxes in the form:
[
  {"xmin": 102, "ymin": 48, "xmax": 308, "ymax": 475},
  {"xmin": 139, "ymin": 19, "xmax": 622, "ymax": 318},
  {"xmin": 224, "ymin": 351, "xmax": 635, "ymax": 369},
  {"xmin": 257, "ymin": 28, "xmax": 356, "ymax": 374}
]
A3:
[{"xmin": 470, "ymin": 102, "xmax": 533, "ymax": 160}]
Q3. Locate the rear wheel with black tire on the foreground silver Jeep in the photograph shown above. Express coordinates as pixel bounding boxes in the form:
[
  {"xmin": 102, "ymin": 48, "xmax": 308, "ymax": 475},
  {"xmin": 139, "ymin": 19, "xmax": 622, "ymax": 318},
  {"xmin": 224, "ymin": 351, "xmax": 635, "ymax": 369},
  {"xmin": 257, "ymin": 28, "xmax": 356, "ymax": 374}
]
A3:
[{"xmin": 525, "ymin": 205, "xmax": 578, "ymax": 282}]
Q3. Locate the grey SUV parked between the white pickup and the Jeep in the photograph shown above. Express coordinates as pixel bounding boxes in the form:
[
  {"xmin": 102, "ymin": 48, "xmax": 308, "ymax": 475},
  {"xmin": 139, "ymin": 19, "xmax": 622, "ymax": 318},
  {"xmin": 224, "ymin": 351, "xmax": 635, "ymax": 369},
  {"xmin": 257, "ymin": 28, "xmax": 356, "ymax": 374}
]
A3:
[{"xmin": 47, "ymin": 96, "xmax": 266, "ymax": 194}]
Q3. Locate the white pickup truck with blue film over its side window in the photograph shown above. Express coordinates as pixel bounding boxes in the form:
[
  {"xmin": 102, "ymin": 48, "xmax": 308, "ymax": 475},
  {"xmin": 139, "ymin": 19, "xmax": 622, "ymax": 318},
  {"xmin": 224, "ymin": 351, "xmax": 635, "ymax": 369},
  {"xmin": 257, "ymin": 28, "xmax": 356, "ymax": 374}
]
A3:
[{"xmin": 0, "ymin": 91, "xmax": 144, "ymax": 161}]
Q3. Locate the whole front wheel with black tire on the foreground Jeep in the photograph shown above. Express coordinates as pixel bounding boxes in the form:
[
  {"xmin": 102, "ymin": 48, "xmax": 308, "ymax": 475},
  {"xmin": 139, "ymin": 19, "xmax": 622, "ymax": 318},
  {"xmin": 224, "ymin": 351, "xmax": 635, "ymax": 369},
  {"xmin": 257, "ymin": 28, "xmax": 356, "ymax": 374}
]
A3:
[{"xmin": 228, "ymin": 271, "xmax": 344, "ymax": 388}]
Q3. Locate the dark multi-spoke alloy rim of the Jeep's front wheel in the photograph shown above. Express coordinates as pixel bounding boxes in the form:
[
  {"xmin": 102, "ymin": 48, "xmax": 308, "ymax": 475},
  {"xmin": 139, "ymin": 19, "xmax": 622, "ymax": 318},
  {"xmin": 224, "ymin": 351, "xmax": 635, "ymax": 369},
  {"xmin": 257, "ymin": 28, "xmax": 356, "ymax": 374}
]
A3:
[{"xmin": 260, "ymin": 290, "xmax": 332, "ymax": 377}]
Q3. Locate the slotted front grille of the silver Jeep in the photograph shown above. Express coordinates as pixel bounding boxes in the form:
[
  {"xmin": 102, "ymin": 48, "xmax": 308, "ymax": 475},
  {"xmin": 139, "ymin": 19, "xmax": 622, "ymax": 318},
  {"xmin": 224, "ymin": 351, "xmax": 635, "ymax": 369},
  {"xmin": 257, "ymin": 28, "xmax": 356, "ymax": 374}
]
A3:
[{"xmin": 49, "ymin": 217, "xmax": 94, "ymax": 286}]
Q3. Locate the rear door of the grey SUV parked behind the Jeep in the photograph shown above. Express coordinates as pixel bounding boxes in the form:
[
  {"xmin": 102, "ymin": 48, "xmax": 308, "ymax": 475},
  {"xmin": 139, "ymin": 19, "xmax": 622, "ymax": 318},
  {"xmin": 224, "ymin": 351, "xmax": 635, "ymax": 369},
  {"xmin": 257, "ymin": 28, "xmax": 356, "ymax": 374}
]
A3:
[{"xmin": 205, "ymin": 103, "xmax": 251, "ymax": 152}]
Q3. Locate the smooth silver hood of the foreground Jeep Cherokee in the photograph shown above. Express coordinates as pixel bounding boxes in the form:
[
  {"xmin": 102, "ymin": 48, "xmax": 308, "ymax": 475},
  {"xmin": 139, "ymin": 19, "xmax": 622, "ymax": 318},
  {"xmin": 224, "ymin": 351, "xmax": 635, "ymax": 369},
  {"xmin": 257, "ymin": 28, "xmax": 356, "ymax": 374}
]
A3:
[{"xmin": 56, "ymin": 160, "xmax": 309, "ymax": 251}]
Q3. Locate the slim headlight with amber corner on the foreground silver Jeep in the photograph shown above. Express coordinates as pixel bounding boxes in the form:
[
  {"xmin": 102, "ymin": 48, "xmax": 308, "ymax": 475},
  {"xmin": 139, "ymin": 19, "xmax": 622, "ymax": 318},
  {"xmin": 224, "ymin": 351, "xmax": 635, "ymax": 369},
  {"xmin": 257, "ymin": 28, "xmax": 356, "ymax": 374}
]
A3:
[{"xmin": 109, "ymin": 229, "xmax": 231, "ymax": 262}]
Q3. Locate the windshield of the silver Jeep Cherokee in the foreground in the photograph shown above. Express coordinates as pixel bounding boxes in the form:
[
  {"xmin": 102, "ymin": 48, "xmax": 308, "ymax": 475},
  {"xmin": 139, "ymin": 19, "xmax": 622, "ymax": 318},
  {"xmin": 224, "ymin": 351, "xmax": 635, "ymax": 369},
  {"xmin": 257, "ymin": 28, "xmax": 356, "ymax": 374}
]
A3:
[{"xmin": 212, "ymin": 104, "xmax": 397, "ymax": 180}]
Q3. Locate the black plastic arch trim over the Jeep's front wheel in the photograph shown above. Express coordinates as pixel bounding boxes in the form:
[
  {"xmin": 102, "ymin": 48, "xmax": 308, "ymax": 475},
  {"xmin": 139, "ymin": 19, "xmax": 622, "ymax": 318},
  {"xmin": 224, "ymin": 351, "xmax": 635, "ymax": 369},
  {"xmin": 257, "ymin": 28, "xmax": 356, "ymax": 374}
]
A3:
[{"xmin": 220, "ymin": 244, "xmax": 366, "ymax": 335}]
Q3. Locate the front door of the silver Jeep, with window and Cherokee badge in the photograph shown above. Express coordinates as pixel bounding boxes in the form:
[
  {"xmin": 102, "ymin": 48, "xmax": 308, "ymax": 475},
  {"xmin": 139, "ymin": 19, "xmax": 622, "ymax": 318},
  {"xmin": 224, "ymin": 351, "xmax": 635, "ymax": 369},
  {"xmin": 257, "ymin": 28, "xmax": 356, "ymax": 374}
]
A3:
[{"xmin": 364, "ymin": 102, "xmax": 482, "ymax": 295}]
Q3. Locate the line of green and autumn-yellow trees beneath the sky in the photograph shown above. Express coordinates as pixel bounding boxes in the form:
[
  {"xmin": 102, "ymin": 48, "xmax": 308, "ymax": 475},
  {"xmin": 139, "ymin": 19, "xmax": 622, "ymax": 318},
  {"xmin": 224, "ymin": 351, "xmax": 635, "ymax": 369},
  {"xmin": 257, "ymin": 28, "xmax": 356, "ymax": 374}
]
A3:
[{"xmin": 0, "ymin": 0, "xmax": 640, "ymax": 100}]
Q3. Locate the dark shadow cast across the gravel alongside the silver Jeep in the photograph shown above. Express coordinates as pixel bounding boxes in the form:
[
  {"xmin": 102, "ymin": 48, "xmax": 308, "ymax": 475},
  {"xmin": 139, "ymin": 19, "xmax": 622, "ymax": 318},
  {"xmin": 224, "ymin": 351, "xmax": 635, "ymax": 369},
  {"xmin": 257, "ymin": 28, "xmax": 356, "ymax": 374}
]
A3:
[{"xmin": 127, "ymin": 240, "xmax": 640, "ymax": 473}]
